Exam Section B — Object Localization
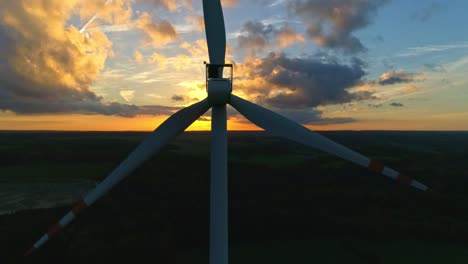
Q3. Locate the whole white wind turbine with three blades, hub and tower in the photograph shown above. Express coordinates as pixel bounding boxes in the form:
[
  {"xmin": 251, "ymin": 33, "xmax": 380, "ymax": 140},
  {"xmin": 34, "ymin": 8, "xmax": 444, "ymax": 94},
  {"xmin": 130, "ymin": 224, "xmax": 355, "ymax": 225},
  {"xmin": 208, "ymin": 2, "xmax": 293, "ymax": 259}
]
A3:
[{"xmin": 26, "ymin": 0, "xmax": 430, "ymax": 264}]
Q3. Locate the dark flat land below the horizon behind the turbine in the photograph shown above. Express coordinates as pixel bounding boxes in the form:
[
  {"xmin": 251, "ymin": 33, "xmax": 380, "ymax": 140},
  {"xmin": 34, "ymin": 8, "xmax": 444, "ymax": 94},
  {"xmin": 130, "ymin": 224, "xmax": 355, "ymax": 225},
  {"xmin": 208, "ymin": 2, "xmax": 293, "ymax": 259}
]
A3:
[{"xmin": 0, "ymin": 131, "xmax": 468, "ymax": 263}]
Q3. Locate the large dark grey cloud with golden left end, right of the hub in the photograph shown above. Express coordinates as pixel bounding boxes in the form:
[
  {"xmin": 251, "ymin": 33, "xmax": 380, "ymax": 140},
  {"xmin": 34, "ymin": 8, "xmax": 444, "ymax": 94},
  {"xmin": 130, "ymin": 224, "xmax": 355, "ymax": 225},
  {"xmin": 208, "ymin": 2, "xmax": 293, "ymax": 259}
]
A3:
[{"xmin": 236, "ymin": 53, "xmax": 374, "ymax": 109}]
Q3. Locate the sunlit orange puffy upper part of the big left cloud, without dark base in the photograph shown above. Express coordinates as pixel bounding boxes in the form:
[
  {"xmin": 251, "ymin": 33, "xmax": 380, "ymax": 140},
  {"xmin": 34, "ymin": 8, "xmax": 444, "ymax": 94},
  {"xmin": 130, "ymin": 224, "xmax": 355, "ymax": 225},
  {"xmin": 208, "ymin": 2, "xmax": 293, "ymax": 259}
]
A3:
[{"xmin": 0, "ymin": 0, "xmax": 112, "ymax": 95}]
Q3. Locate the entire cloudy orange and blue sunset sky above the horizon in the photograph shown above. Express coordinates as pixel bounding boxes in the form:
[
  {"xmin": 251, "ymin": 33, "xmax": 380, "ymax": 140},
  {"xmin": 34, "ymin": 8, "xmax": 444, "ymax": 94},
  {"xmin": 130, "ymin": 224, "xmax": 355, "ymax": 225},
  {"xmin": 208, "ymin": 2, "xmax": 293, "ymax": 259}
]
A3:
[{"xmin": 0, "ymin": 0, "xmax": 468, "ymax": 131}]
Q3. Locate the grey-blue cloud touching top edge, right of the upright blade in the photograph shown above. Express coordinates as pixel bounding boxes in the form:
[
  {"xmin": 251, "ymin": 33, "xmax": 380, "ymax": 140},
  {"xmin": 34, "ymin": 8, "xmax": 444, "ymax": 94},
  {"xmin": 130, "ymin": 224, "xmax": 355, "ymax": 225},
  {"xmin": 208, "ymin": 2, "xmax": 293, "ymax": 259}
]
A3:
[{"xmin": 288, "ymin": 0, "xmax": 387, "ymax": 53}]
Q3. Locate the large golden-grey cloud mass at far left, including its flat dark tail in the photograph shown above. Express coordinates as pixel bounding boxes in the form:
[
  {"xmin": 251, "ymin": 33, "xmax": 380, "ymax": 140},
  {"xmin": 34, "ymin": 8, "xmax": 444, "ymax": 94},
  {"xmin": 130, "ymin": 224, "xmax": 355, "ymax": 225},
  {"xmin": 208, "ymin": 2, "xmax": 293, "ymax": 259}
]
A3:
[{"xmin": 0, "ymin": 0, "xmax": 174, "ymax": 116}]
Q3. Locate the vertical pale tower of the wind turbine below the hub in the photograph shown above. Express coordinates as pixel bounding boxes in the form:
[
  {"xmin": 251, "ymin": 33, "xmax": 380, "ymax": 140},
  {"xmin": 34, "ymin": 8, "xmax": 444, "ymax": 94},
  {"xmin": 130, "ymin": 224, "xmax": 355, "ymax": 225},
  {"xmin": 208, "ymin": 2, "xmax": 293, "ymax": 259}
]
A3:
[{"xmin": 209, "ymin": 105, "xmax": 228, "ymax": 264}]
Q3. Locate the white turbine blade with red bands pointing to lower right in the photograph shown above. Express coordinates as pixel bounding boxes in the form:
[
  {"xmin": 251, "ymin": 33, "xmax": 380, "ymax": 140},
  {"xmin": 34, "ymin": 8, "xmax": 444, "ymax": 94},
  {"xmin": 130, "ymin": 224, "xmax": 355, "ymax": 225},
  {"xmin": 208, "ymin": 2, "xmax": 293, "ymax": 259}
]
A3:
[{"xmin": 230, "ymin": 95, "xmax": 429, "ymax": 191}]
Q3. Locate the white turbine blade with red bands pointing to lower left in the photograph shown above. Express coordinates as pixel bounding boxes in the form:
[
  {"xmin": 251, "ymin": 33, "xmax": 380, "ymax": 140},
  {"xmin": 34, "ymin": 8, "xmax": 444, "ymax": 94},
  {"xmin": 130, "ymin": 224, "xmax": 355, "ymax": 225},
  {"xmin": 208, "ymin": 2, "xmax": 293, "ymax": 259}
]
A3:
[{"xmin": 26, "ymin": 99, "xmax": 210, "ymax": 255}]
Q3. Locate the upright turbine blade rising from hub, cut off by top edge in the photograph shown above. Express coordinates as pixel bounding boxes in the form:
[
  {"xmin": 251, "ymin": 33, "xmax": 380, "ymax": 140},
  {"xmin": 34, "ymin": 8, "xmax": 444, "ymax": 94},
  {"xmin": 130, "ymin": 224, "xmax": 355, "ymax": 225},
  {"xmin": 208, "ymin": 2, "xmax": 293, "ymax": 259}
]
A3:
[{"xmin": 203, "ymin": 0, "xmax": 226, "ymax": 64}]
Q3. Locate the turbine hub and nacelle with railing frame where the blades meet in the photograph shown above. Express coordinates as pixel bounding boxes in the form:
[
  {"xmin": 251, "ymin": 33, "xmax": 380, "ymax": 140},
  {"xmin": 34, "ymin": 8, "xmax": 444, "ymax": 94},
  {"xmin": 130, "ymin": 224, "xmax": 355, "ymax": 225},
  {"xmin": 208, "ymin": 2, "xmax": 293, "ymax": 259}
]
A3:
[{"xmin": 206, "ymin": 64, "xmax": 232, "ymax": 105}]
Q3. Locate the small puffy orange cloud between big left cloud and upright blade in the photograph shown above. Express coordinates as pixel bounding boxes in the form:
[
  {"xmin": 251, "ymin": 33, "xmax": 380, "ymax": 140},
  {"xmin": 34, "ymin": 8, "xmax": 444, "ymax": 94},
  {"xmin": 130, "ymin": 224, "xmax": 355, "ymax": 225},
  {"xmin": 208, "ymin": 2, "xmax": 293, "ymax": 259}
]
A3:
[{"xmin": 135, "ymin": 12, "xmax": 179, "ymax": 48}]
